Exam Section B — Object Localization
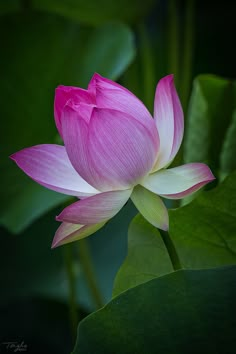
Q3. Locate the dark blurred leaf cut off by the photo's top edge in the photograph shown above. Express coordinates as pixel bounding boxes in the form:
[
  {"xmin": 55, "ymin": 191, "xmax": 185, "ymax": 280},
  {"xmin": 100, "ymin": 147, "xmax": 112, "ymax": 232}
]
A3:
[{"xmin": 32, "ymin": 0, "xmax": 155, "ymax": 25}]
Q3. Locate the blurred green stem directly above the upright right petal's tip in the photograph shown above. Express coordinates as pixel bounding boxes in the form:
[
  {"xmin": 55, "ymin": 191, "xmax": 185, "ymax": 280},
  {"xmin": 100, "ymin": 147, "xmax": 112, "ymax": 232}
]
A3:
[{"xmin": 167, "ymin": 0, "xmax": 180, "ymax": 89}]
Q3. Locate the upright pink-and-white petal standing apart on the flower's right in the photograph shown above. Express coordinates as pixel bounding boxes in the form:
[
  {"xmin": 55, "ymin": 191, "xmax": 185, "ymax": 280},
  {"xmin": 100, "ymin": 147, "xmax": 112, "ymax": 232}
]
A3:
[{"xmin": 154, "ymin": 75, "xmax": 184, "ymax": 171}]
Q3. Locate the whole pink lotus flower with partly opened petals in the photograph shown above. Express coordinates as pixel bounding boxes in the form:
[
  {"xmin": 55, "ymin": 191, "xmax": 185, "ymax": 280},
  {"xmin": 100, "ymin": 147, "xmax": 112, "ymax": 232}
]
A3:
[{"xmin": 11, "ymin": 74, "xmax": 214, "ymax": 247}]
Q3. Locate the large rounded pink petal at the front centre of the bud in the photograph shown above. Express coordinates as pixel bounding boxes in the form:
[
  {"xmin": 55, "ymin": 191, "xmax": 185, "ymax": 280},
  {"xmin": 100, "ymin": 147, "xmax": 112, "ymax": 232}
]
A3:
[{"xmin": 88, "ymin": 108, "xmax": 158, "ymax": 190}]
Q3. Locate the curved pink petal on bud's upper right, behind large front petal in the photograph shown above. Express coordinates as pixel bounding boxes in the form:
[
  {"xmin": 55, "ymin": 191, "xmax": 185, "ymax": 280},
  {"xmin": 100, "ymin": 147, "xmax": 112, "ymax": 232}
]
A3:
[{"xmin": 88, "ymin": 74, "xmax": 158, "ymax": 145}]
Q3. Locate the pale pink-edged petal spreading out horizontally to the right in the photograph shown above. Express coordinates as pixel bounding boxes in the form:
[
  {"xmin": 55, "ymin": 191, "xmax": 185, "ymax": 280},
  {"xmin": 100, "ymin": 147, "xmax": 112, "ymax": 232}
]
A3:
[{"xmin": 142, "ymin": 163, "xmax": 215, "ymax": 199}]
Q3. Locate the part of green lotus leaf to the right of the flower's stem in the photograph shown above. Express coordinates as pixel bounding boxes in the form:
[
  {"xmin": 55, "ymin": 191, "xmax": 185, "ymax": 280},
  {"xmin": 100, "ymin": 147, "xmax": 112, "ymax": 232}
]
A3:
[{"xmin": 170, "ymin": 173, "xmax": 236, "ymax": 268}]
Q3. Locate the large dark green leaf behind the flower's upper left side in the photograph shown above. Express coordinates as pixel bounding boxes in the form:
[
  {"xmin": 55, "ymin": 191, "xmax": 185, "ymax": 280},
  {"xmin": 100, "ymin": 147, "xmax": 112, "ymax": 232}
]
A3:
[{"xmin": 0, "ymin": 12, "xmax": 134, "ymax": 232}]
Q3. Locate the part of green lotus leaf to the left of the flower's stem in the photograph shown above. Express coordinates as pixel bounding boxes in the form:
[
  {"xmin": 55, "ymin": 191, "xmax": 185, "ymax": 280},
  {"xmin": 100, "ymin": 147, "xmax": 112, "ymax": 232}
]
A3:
[{"xmin": 113, "ymin": 214, "xmax": 173, "ymax": 295}]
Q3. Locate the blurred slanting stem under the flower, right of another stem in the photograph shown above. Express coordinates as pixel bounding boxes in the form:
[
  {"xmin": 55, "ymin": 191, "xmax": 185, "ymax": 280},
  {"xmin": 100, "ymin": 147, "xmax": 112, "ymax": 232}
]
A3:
[{"xmin": 79, "ymin": 238, "xmax": 104, "ymax": 308}]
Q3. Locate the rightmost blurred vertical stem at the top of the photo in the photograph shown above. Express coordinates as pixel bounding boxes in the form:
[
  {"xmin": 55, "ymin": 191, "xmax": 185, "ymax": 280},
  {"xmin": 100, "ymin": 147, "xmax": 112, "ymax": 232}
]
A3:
[{"xmin": 181, "ymin": 0, "xmax": 195, "ymax": 113}]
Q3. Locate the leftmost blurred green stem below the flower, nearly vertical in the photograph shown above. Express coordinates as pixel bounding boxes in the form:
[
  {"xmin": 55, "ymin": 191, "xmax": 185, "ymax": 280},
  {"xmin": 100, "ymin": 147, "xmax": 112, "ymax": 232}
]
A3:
[{"xmin": 63, "ymin": 244, "xmax": 79, "ymax": 340}]
